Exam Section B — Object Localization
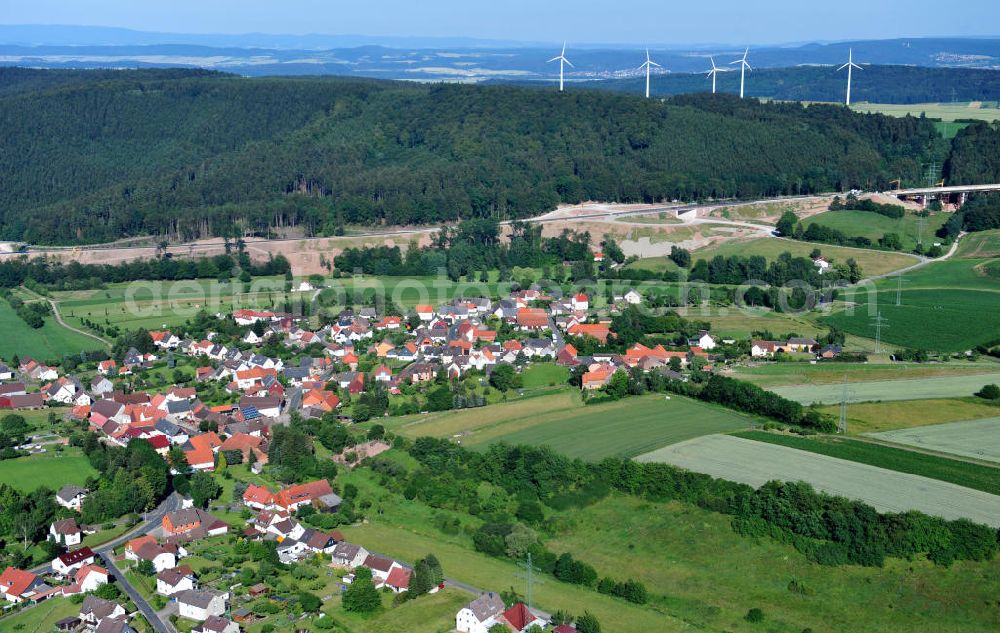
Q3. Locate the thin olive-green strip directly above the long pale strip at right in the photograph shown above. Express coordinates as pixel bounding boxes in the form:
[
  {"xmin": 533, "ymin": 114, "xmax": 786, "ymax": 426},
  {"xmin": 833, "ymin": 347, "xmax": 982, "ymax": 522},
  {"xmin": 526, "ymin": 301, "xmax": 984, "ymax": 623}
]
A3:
[{"xmin": 733, "ymin": 361, "xmax": 1000, "ymax": 390}]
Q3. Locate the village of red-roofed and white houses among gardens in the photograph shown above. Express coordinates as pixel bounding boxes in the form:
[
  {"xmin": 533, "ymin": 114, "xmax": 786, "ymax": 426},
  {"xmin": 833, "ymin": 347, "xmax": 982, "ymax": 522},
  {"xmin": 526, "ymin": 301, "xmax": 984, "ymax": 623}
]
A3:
[{"xmin": 0, "ymin": 288, "xmax": 840, "ymax": 633}]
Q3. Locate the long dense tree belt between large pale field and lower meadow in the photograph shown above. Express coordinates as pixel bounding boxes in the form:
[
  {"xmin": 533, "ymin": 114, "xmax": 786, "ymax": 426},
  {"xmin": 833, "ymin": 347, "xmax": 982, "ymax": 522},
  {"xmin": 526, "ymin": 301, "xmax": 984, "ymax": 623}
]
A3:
[{"xmin": 402, "ymin": 437, "xmax": 998, "ymax": 578}]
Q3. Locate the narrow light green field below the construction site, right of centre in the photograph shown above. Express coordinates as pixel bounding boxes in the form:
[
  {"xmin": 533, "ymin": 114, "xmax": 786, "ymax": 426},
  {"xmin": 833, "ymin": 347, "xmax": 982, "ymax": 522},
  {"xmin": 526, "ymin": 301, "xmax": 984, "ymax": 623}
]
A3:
[{"xmin": 691, "ymin": 237, "xmax": 917, "ymax": 275}]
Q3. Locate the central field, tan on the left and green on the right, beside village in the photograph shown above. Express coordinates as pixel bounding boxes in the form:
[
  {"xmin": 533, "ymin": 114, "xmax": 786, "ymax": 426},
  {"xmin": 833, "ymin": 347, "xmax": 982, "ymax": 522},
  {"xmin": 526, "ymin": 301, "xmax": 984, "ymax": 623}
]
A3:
[{"xmin": 386, "ymin": 392, "xmax": 755, "ymax": 460}]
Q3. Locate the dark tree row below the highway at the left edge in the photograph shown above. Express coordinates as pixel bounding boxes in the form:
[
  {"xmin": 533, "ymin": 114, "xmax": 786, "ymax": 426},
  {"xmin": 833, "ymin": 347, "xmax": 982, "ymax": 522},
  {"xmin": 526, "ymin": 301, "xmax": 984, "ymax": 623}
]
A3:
[{"xmin": 0, "ymin": 253, "xmax": 292, "ymax": 292}]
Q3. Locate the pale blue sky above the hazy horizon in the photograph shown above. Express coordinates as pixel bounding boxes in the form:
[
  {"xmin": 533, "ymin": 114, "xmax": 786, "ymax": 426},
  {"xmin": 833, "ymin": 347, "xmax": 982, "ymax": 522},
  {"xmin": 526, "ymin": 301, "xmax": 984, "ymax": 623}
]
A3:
[{"xmin": 0, "ymin": 0, "xmax": 1000, "ymax": 44}]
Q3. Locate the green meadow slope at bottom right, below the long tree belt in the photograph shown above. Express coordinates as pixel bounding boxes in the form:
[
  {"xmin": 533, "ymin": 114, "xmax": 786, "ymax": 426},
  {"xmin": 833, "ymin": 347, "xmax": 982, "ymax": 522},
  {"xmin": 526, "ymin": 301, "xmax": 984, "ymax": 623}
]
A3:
[{"xmin": 340, "ymin": 454, "xmax": 1000, "ymax": 633}]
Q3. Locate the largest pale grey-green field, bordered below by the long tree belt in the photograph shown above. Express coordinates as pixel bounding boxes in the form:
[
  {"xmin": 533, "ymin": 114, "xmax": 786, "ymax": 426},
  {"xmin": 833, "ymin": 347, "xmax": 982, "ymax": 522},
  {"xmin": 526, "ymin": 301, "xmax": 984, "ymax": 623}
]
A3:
[{"xmin": 637, "ymin": 435, "xmax": 1000, "ymax": 527}]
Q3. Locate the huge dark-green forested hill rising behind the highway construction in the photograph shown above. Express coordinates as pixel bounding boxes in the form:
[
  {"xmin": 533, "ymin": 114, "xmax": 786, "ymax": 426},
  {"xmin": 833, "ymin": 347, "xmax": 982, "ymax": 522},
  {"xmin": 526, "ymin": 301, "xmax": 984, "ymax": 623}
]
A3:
[{"xmin": 0, "ymin": 71, "xmax": 968, "ymax": 243}]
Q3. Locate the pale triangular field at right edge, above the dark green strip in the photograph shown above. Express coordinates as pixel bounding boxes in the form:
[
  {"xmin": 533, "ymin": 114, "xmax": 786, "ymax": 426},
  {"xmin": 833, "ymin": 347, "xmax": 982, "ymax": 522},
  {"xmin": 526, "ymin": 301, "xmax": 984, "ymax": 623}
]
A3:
[{"xmin": 872, "ymin": 417, "xmax": 1000, "ymax": 463}]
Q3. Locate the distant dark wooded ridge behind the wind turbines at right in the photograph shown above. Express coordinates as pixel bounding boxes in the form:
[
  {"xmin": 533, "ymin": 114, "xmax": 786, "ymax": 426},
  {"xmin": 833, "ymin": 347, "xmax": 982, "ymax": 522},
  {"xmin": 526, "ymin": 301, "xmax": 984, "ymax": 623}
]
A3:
[{"xmin": 585, "ymin": 64, "xmax": 1000, "ymax": 103}]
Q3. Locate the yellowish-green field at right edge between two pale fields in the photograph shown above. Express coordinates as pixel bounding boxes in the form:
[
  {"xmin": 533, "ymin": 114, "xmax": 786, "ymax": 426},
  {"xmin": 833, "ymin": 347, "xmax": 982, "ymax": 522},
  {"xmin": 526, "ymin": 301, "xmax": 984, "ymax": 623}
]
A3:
[{"xmin": 821, "ymin": 398, "xmax": 1000, "ymax": 435}]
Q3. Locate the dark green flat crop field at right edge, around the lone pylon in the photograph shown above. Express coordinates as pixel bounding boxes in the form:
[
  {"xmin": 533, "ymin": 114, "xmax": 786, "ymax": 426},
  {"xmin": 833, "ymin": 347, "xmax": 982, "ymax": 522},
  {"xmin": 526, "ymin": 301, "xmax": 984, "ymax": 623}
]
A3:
[{"xmin": 820, "ymin": 289, "xmax": 1000, "ymax": 352}]
